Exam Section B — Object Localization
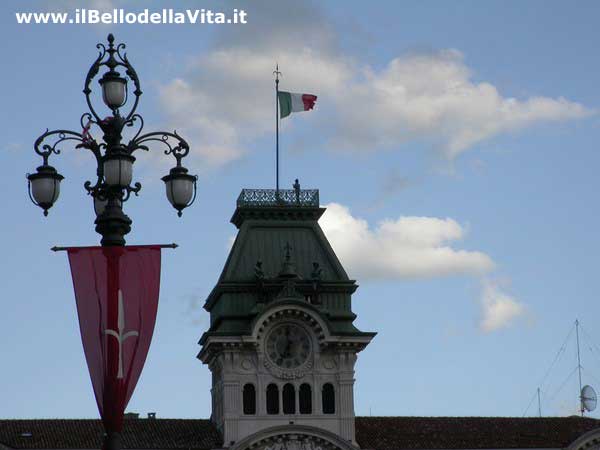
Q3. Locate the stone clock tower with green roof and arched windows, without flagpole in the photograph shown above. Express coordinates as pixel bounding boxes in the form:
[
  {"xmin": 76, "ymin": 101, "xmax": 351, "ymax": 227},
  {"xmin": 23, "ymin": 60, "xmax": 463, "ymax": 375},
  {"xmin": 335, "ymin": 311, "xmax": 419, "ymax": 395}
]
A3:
[{"xmin": 198, "ymin": 182, "xmax": 375, "ymax": 450}]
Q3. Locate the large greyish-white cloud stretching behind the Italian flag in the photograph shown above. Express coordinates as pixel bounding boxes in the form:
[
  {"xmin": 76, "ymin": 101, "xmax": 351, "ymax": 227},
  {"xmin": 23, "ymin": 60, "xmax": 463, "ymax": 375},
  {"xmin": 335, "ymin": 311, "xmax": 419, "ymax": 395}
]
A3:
[{"xmin": 162, "ymin": 7, "xmax": 593, "ymax": 165}]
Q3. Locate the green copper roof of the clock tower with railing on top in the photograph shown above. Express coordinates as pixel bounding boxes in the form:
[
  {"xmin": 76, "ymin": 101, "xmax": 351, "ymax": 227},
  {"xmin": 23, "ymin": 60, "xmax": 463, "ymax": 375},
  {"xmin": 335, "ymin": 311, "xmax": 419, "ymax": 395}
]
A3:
[{"xmin": 201, "ymin": 188, "xmax": 372, "ymax": 342}]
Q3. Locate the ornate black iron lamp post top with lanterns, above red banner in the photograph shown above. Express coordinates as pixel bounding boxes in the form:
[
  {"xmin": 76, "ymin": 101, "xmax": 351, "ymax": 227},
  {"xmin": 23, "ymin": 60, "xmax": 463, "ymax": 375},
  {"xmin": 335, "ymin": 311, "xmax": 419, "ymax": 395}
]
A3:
[{"xmin": 27, "ymin": 34, "xmax": 197, "ymax": 246}]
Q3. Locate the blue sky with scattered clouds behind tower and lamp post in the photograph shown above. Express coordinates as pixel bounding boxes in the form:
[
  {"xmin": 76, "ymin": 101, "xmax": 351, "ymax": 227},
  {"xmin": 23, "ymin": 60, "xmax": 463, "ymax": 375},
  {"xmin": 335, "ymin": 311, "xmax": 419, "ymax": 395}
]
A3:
[{"xmin": 0, "ymin": 0, "xmax": 600, "ymax": 418}]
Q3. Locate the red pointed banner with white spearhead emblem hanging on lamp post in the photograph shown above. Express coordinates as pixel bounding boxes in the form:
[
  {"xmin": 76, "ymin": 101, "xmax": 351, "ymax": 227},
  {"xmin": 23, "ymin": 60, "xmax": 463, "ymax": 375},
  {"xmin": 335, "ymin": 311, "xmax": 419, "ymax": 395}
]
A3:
[{"xmin": 67, "ymin": 246, "xmax": 160, "ymax": 433}]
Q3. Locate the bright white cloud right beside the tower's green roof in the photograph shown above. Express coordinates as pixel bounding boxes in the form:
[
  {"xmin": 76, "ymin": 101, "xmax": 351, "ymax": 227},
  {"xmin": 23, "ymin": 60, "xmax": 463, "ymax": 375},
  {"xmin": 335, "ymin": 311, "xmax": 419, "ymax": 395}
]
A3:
[{"xmin": 319, "ymin": 203, "xmax": 494, "ymax": 280}]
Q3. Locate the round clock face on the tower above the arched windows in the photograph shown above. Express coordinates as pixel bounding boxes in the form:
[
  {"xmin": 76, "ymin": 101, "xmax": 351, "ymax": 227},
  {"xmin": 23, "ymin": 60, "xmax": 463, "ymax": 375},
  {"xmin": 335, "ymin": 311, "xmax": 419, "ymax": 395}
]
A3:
[{"xmin": 266, "ymin": 323, "xmax": 311, "ymax": 369}]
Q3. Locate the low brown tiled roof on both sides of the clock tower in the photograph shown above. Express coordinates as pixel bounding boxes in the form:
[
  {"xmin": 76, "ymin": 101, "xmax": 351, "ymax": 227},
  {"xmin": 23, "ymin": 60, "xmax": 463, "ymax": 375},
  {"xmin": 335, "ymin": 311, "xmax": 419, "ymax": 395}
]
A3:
[{"xmin": 0, "ymin": 417, "xmax": 600, "ymax": 450}]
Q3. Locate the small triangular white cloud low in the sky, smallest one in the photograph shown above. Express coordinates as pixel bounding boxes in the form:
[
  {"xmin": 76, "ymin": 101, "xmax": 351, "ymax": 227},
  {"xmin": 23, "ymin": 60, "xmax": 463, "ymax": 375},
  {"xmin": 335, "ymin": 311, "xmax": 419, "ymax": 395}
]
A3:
[{"xmin": 479, "ymin": 280, "xmax": 525, "ymax": 333}]
